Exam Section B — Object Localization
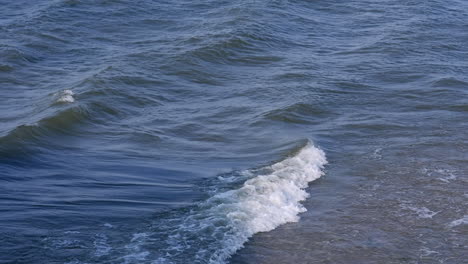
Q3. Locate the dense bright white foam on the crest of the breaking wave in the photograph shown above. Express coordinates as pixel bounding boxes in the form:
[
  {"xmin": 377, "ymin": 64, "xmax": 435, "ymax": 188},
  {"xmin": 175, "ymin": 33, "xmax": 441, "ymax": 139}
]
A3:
[{"xmin": 218, "ymin": 146, "xmax": 326, "ymax": 236}]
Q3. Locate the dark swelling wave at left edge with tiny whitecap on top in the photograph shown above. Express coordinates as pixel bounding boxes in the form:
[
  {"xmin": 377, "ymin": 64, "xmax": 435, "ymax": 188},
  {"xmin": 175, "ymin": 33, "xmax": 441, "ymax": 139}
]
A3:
[{"xmin": 0, "ymin": 96, "xmax": 124, "ymax": 159}]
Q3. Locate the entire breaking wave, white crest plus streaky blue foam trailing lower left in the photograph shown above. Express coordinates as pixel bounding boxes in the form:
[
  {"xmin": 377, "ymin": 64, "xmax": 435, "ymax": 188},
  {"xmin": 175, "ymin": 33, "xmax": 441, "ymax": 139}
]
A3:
[{"xmin": 124, "ymin": 143, "xmax": 327, "ymax": 264}]
